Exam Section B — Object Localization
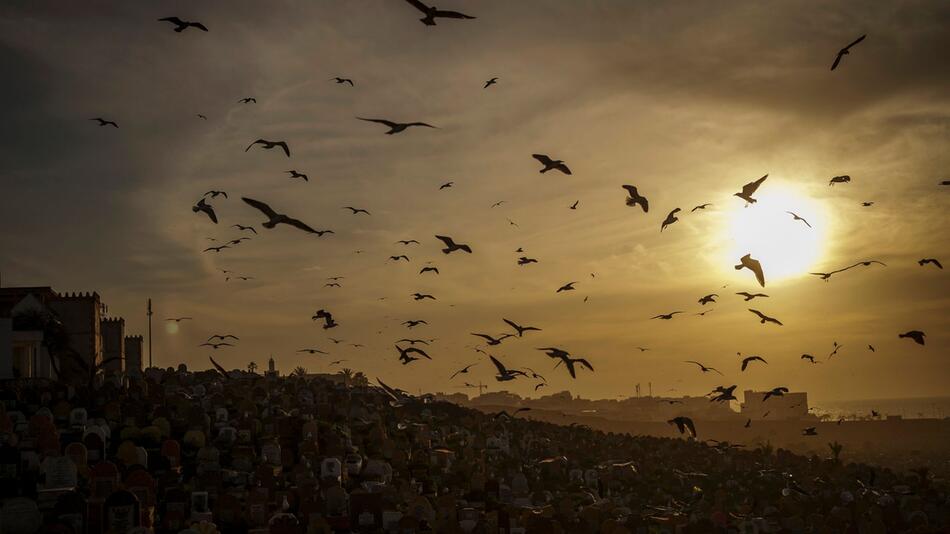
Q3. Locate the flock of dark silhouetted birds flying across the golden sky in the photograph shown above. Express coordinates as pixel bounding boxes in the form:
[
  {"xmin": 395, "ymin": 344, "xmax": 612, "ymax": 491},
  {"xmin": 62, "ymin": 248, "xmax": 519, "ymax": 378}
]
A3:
[{"xmin": 78, "ymin": 0, "xmax": 950, "ymax": 444}]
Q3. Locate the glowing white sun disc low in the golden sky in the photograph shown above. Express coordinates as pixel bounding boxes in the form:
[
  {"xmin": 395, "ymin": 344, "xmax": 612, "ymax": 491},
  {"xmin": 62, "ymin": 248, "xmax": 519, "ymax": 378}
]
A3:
[{"xmin": 725, "ymin": 183, "xmax": 827, "ymax": 284}]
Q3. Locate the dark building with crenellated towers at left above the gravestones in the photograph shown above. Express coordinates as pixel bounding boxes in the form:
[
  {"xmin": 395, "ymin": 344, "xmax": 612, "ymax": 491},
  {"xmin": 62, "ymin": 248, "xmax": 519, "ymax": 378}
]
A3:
[{"xmin": 0, "ymin": 286, "xmax": 141, "ymax": 379}]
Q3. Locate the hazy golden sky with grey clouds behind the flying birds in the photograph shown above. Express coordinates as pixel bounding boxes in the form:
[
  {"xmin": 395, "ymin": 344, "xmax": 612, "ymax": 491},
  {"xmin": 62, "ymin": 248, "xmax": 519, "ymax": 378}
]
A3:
[{"xmin": 0, "ymin": 0, "xmax": 950, "ymax": 399}]
